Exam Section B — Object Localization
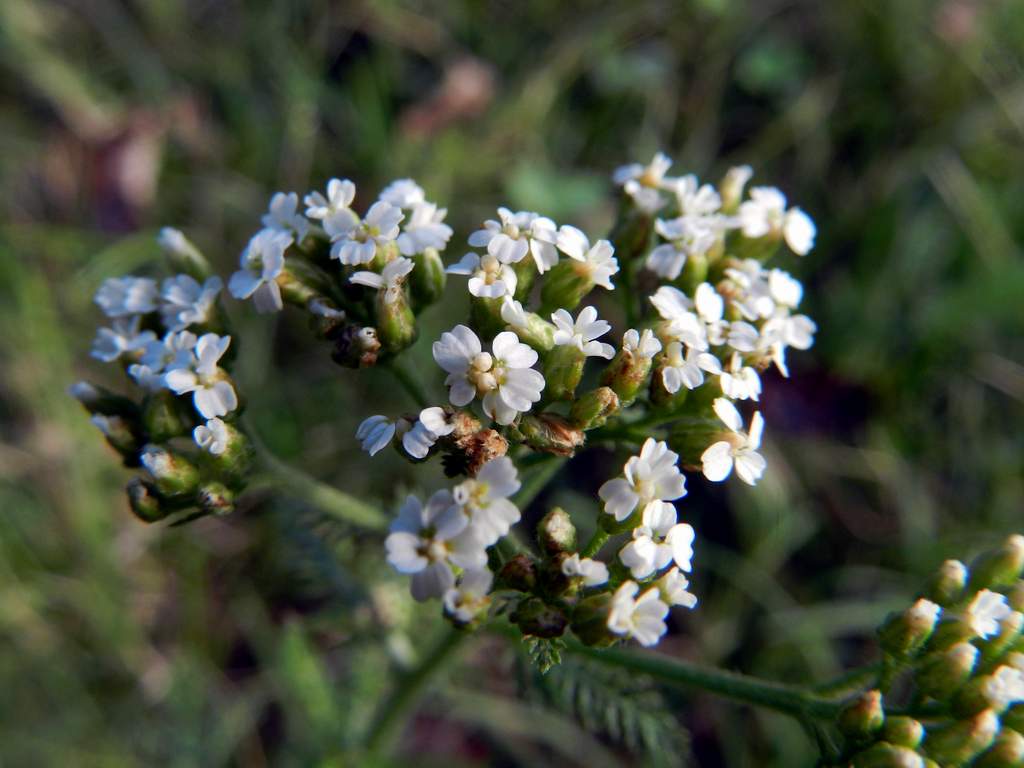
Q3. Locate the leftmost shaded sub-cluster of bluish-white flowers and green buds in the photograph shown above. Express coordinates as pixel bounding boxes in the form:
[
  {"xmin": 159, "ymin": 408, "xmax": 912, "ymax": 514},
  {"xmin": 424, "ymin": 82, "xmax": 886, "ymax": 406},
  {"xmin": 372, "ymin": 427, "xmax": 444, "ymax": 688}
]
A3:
[{"xmin": 71, "ymin": 229, "xmax": 251, "ymax": 521}]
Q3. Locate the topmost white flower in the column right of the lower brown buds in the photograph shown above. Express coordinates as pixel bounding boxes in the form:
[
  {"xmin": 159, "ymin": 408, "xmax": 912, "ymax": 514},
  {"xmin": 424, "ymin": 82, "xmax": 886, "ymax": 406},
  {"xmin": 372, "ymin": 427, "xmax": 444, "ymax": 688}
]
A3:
[{"xmin": 598, "ymin": 437, "xmax": 686, "ymax": 522}]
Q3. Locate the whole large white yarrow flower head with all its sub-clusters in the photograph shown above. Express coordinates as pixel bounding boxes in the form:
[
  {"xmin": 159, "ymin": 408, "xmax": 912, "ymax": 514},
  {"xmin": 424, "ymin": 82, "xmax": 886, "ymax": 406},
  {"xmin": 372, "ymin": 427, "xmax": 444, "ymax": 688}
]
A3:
[{"xmin": 76, "ymin": 155, "xmax": 815, "ymax": 645}]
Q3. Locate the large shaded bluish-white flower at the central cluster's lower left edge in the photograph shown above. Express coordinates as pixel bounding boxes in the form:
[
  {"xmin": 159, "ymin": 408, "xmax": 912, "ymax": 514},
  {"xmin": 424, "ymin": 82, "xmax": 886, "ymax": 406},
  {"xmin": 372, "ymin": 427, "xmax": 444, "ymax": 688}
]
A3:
[{"xmin": 384, "ymin": 490, "xmax": 487, "ymax": 601}]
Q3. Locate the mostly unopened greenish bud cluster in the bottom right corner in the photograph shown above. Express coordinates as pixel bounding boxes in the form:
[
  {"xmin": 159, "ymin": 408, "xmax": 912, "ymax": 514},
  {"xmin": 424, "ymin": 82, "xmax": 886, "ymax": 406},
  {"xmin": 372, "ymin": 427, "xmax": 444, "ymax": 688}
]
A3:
[{"xmin": 836, "ymin": 536, "xmax": 1024, "ymax": 768}]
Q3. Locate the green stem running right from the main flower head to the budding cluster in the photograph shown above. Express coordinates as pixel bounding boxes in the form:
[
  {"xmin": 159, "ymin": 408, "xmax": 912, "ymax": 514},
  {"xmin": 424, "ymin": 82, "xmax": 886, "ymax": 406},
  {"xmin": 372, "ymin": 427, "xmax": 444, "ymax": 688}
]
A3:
[{"xmin": 566, "ymin": 640, "xmax": 844, "ymax": 720}]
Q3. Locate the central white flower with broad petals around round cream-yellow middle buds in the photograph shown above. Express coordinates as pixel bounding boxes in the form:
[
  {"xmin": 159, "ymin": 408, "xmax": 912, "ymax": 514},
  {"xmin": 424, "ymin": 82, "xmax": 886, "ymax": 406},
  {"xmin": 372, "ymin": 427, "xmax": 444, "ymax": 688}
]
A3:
[{"xmin": 433, "ymin": 326, "xmax": 545, "ymax": 425}]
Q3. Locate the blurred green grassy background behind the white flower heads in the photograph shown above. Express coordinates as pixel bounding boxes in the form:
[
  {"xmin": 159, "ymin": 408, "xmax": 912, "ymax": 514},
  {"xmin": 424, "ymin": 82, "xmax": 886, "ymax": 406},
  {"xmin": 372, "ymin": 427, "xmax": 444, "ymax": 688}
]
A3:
[{"xmin": 0, "ymin": 0, "xmax": 1024, "ymax": 768}]
